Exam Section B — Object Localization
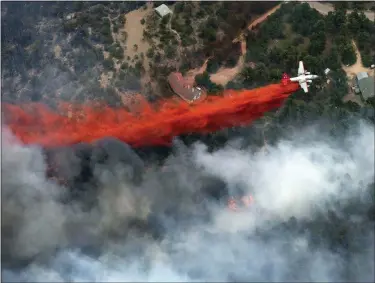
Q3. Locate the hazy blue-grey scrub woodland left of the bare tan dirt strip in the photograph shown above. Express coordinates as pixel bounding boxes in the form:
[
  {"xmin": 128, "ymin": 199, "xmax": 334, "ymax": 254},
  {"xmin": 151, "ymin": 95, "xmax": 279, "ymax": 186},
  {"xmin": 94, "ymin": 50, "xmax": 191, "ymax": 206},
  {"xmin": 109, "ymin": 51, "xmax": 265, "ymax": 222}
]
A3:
[{"xmin": 1, "ymin": 2, "xmax": 144, "ymax": 106}]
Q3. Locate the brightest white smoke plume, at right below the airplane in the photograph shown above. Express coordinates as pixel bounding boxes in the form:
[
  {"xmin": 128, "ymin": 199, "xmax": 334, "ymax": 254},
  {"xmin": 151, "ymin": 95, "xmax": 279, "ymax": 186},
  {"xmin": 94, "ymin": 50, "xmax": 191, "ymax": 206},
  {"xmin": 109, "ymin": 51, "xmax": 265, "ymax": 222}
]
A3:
[{"xmin": 195, "ymin": 120, "xmax": 374, "ymax": 220}]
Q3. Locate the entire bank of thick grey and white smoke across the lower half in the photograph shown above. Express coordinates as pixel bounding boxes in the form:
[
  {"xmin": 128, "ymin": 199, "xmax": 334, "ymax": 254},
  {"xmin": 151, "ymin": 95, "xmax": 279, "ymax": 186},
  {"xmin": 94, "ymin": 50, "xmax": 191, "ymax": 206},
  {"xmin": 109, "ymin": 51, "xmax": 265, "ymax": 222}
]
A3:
[{"xmin": 2, "ymin": 123, "xmax": 375, "ymax": 282}]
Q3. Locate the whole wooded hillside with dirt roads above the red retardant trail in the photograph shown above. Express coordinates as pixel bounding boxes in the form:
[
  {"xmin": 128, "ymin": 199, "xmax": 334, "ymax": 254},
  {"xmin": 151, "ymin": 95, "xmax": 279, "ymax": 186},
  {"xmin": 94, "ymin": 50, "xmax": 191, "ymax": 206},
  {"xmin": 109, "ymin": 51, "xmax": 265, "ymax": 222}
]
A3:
[{"xmin": 2, "ymin": 2, "xmax": 375, "ymax": 126}]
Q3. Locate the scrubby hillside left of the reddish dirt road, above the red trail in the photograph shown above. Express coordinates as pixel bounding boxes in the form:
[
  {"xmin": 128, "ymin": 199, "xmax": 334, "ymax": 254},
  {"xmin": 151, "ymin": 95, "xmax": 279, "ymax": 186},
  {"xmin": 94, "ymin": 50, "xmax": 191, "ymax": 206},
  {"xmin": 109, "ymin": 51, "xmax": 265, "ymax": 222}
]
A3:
[{"xmin": 2, "ymin": 2, "xmax": 275, "ymax": 106}]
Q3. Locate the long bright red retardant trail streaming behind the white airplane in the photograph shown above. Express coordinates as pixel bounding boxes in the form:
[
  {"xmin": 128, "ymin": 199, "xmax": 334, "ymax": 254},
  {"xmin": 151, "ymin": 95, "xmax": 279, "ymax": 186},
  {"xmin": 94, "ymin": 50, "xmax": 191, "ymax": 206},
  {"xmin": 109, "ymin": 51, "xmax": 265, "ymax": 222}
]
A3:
[{"xmin": 2, "ymin": 83, "xmax": 299, "ymax": 147}]
